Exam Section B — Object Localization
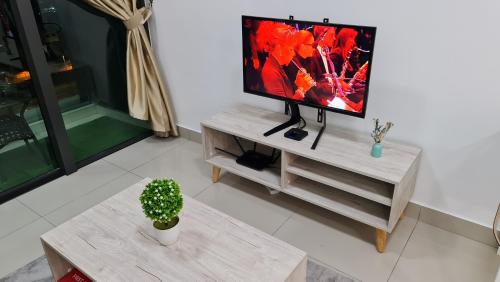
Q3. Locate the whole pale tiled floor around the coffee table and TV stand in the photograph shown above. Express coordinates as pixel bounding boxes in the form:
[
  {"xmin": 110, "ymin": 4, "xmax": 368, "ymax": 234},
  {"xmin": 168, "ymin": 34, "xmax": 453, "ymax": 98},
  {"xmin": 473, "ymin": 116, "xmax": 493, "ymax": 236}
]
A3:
[{"xmin": 0, "ymin": 138, "xmax": 499, "ymax": 281}]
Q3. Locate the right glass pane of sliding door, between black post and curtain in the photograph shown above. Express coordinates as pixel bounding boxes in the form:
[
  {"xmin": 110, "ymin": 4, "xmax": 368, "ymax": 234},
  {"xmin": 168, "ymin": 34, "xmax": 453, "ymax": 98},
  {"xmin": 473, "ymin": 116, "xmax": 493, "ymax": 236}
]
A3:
[{"xmin": 32, "ymin": 0, "xmax": 150, "ymax": 162}]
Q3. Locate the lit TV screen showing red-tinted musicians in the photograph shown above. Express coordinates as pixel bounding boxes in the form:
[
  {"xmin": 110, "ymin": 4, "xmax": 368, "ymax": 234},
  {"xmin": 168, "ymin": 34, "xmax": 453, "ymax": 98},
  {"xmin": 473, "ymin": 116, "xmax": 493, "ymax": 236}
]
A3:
[{"xmin": 242, "ymin": 16, "xmax": 376, "ymax": 117}]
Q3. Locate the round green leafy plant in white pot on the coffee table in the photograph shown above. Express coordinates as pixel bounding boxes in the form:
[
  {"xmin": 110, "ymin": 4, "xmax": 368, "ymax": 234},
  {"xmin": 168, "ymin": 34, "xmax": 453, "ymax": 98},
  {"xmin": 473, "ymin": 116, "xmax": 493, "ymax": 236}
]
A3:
[{"xmin": 139, "ymin": 179, "xmax": 183, "ymax": 245}]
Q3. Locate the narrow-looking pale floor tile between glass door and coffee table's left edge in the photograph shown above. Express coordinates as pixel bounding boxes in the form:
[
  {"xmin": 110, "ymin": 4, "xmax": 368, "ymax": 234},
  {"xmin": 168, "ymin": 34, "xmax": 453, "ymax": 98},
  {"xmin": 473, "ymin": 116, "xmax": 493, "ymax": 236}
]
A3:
[{"xmin": 45, "ymin": 173, "xmax": 141, "ymax": 225}]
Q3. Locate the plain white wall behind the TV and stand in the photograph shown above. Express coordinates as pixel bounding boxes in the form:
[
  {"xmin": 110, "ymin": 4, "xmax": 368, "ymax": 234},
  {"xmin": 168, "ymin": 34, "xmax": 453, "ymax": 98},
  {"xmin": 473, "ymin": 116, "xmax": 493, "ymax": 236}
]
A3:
[{"xmin": 151, "ymin": 0, "xmax": 500, "ymax": 226}]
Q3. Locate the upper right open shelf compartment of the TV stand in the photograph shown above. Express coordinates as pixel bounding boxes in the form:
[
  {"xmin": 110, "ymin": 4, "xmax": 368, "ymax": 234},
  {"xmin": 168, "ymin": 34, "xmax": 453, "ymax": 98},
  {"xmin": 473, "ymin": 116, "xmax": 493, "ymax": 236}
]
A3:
[{"xmin": 286, "ymin": 156, "xmax": 394, "ymax": 206}]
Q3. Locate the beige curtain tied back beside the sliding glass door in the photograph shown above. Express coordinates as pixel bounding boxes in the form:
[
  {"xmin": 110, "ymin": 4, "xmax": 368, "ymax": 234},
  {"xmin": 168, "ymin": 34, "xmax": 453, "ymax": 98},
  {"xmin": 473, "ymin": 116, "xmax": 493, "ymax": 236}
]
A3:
[{"xmin": 85, "ymin": 0, "xmax": 178, "ymax": 137}]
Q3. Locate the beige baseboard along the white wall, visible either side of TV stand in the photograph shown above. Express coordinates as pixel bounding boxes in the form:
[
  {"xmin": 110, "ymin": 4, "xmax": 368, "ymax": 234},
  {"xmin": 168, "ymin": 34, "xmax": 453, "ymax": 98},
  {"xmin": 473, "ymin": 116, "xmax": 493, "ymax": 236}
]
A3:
[{"xmin": 179, "ymin": 125, "xmax": 498, "ymax": 248}]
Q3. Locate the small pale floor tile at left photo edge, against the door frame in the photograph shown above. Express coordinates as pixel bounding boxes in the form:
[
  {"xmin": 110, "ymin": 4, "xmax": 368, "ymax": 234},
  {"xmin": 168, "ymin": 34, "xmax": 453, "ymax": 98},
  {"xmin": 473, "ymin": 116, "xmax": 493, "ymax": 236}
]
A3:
[{"xmin": 0, "ymin": 200, "xmax": 40, "ymax": 238}]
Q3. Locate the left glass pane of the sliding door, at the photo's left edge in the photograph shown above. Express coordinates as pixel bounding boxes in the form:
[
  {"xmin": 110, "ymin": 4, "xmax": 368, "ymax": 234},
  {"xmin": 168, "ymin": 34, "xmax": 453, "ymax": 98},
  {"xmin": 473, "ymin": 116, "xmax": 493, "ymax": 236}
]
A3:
[{"xmin": 0, "ymin": 1, "xmax": 58, "ymax": 193}]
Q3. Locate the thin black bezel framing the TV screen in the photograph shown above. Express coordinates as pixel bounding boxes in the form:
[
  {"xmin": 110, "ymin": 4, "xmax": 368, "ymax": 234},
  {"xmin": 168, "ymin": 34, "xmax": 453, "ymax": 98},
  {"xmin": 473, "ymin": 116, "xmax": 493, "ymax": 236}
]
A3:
[{"xmin": 241, "ymin": 15, "xmax": 377, "ymax": 118}]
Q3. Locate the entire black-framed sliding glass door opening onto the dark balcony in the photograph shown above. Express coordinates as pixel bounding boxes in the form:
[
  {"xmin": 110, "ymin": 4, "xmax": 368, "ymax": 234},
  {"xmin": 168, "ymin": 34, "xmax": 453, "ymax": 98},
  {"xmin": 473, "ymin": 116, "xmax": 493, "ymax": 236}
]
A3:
[{"xmin": 0, "ymin": 0, "xmax": 152, "ymax": 202}]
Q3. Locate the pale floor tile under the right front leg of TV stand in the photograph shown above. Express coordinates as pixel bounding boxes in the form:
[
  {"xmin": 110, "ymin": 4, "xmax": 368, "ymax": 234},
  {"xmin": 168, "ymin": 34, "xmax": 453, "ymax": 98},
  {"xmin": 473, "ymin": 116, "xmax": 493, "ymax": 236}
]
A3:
[{"xmin": 275, "ymin": 203, "xmax": 416, "ymax": 281}]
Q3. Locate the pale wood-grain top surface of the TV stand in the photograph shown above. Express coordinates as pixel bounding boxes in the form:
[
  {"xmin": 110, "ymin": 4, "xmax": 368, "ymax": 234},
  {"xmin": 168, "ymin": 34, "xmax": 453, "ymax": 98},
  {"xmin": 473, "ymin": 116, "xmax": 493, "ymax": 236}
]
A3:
[{"xmin": 202, "ymin": 105, "xmax": 421, "ymax": 184}]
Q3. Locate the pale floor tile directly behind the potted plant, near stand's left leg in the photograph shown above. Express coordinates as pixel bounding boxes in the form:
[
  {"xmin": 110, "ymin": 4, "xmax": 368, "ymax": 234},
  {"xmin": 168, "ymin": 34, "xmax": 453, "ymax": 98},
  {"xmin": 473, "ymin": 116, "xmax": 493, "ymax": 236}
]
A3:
[{"xmin": 132, "ymin": 140, "xmax": 212, "ymax": 196}]
